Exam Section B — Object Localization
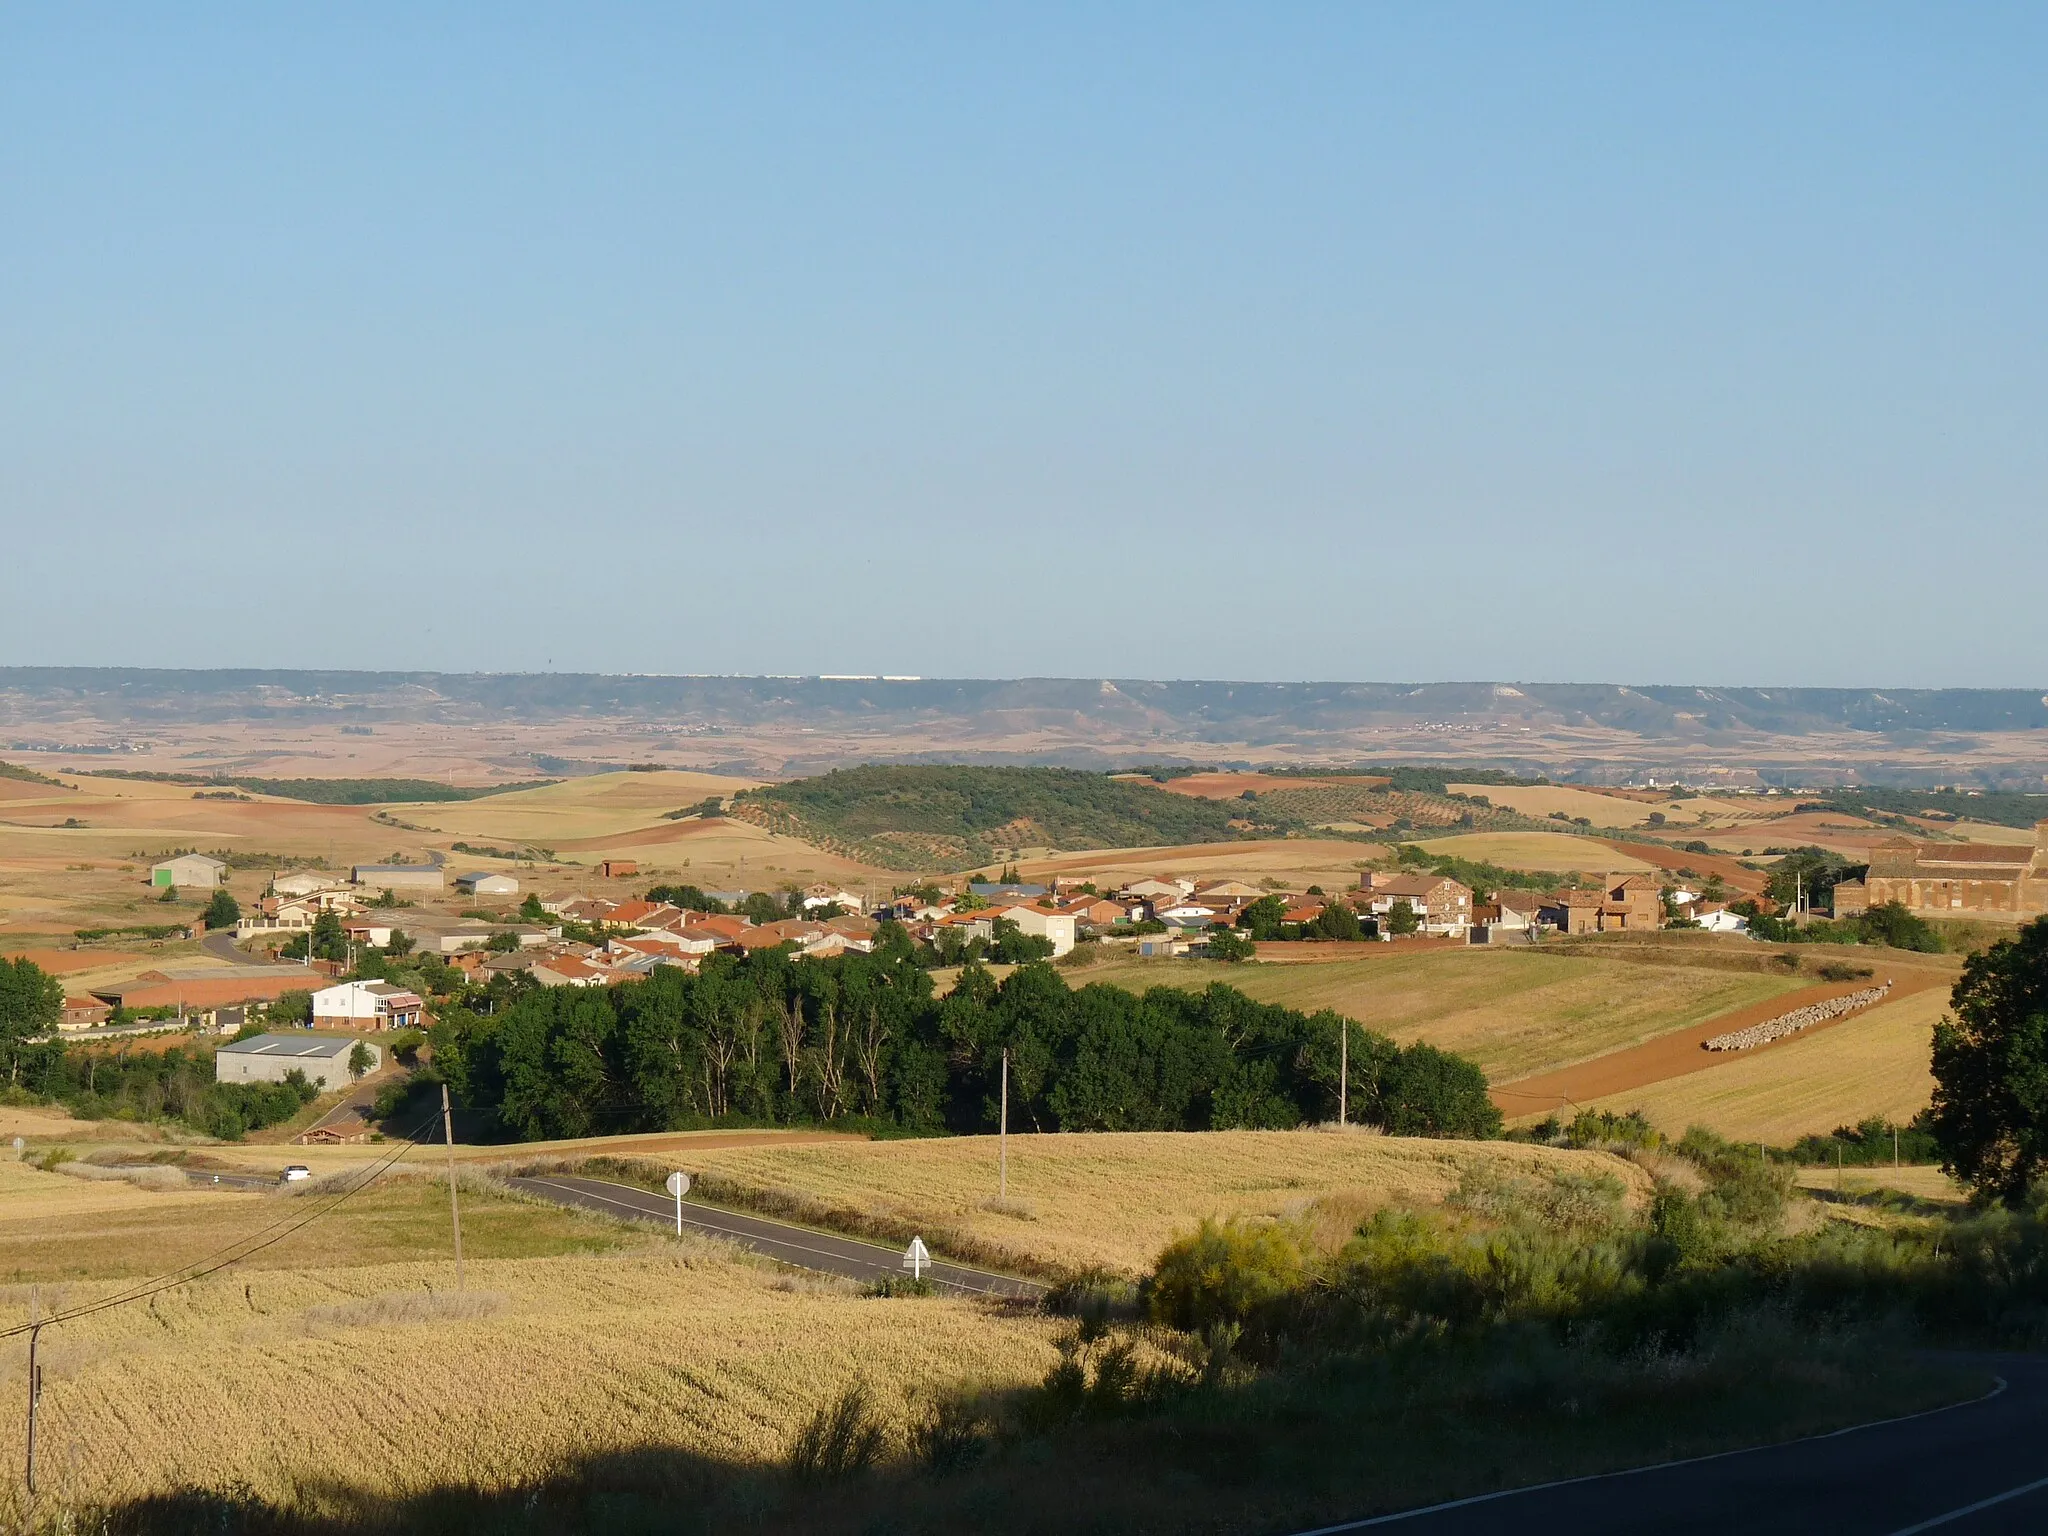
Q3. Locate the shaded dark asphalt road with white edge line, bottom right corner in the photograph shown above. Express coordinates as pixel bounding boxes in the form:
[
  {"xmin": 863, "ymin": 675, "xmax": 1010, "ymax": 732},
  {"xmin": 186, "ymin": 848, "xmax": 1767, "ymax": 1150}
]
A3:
[{"xmin": 1303, "ymin": 1356, "xmax": 2048, "ymax": 1536}]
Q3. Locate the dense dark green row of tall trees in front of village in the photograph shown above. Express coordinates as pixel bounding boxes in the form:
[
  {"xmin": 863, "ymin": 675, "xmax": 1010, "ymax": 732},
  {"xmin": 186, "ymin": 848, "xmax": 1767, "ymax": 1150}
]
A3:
[{"xmin": 430, "ymin": 932, "xmax": 1499, "ymax": 1141}]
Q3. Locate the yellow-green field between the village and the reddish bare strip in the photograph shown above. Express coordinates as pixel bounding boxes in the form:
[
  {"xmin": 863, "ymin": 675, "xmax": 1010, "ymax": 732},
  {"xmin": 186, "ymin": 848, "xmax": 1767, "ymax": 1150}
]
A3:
[{"xmin": 1071, "ymin": 944, "xmax": 1800, "ymax": 1081}]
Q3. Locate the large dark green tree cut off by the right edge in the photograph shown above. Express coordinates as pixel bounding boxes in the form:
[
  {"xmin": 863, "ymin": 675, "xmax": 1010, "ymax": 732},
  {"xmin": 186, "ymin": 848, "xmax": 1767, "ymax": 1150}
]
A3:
[{"xmin": 1927, "ymin": 918, "xmax": 2048, "ymax": 1206}]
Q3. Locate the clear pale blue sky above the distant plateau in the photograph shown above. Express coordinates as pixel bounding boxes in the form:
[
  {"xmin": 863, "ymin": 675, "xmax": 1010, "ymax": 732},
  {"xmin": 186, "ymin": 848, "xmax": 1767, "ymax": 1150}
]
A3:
[{"xmin": 0, "ymin": 4, "xmax": 2048, "ymax": 686}]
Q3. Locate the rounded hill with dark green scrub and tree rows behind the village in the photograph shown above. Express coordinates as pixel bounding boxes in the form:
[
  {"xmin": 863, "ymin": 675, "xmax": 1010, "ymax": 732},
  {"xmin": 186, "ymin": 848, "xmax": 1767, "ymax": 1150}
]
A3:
[{"xmin": 731, "ymin": 766, "xmax": 1247, "ymax": 870}]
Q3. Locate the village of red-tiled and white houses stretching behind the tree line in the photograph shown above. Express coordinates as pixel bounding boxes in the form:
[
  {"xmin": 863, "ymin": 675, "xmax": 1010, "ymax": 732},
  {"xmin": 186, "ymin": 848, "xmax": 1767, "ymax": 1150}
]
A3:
[{"xmin": 48, "ymin": 854, "xmax": 1747, "ymax": 1034}]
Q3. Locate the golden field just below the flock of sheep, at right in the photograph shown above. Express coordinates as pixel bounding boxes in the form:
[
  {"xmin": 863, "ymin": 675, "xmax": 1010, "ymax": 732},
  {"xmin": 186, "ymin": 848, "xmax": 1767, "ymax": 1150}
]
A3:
[{"xmin": 1595, "ymin": 989, "xmax": 1948, "ymax": 1143}]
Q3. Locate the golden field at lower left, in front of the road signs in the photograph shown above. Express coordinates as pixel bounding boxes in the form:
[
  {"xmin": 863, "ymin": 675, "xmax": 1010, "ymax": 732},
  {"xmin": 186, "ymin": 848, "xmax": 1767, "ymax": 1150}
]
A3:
[{"xmin": 0, "ymin": 1169, "xmax": 1057, "ymax": 1516}]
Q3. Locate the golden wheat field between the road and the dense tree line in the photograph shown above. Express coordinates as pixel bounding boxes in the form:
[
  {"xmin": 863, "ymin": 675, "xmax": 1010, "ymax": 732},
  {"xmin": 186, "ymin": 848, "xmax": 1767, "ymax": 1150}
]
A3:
[{"xmin": 684, "ymin": 1128, "xmax": 1649, "ymax": 1274}]
